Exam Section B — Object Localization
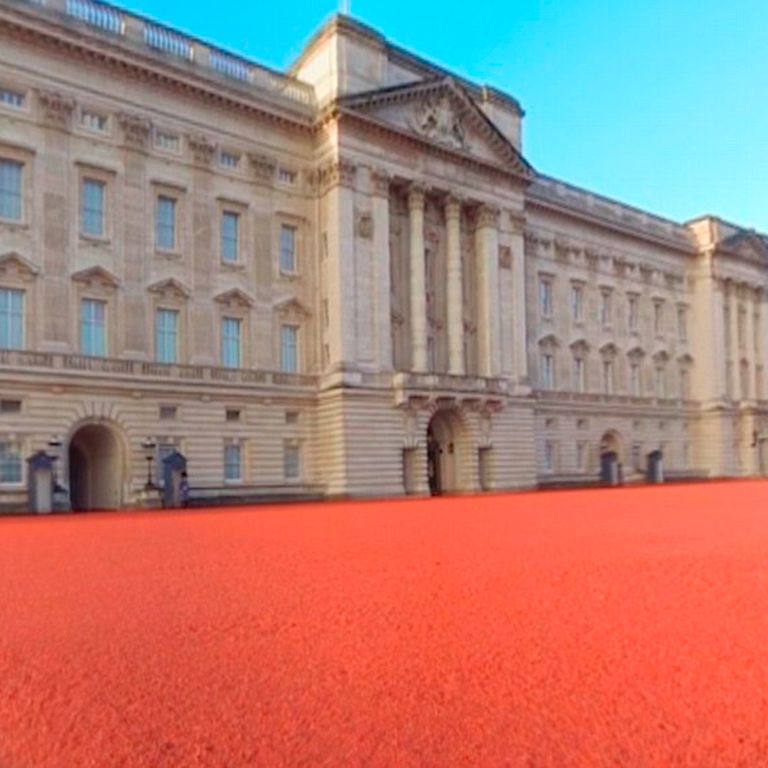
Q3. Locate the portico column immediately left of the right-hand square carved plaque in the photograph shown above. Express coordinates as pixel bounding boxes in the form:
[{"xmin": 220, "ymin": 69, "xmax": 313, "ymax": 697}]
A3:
[{"xmin": 475, "ymin": 205, "xmax": 501, "ymax": 377}]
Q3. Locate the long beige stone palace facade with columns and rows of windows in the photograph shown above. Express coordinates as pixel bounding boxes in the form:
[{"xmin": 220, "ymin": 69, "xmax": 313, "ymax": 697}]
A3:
[{"xmin": 0, "ymin": 0, "xmax": 768, "ymax": 509}]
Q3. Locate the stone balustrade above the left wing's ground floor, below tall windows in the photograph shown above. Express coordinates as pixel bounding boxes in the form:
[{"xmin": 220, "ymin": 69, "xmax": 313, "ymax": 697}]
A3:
[{"xmin": 0, "ymin": 349, "xmax": 317, "ymax": 389}]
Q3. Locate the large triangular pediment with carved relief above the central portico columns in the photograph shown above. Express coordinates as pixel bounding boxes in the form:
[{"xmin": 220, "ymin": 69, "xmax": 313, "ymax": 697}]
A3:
[{"xmin": 339, "ymin": 77, "xmax": 533, "ymax": 178}]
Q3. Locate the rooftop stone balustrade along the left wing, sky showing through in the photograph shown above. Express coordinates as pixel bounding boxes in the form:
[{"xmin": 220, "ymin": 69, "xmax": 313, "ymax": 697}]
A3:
[{"xmin": 13, "ymin": 0, "xmax": 315, "ymax": 107}]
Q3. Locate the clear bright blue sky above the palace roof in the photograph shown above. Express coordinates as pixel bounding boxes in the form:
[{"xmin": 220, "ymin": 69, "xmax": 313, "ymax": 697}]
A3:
[{"xmin": 120, "ymin": 0, "xmax": 768, "ymax": 232}]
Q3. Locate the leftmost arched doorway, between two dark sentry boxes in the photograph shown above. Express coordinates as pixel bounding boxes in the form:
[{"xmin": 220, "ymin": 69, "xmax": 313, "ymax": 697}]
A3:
[{"xmin": 69, "ymin": 424, "xmax": 125, "ymax": 510}]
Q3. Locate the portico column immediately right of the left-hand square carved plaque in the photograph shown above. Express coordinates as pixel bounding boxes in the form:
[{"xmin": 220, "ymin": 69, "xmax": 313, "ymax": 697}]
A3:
[{"xmin": 371, "ymin": 171, "xmax": 392, "ymax": 371}]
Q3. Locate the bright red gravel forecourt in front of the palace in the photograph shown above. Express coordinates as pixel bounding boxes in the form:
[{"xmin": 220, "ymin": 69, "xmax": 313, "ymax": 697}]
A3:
[{"xmin": 0, "ymin": 482, "xmax": 768, "ymax": 768}]
